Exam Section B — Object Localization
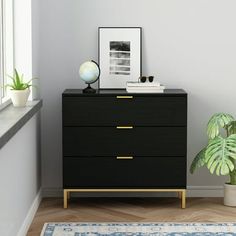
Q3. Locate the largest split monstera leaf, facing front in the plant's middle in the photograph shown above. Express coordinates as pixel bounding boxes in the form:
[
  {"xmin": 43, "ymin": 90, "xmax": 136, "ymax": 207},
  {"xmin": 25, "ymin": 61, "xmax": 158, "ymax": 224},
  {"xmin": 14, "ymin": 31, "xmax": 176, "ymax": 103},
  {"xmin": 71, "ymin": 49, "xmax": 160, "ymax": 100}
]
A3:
[{"xmin": 205, "ymin": 134, "xmax": 236, "ymax": 175}]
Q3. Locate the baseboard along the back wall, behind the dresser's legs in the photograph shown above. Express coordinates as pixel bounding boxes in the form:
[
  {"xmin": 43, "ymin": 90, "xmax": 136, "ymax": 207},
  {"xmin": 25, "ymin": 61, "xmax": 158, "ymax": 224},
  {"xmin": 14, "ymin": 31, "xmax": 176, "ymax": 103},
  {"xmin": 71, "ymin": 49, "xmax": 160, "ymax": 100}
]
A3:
[{"xmin": 43, "ymin": 186, "xmax": 223, "ymax": 197}]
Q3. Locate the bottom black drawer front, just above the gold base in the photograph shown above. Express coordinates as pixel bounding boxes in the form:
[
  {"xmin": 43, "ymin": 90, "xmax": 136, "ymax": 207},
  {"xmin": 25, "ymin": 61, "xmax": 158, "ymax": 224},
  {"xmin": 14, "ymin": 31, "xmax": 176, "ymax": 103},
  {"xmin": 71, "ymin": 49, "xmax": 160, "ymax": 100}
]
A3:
[{"xmin": 63, "ymin": 157, "xmax": 186, "ymax": 188}]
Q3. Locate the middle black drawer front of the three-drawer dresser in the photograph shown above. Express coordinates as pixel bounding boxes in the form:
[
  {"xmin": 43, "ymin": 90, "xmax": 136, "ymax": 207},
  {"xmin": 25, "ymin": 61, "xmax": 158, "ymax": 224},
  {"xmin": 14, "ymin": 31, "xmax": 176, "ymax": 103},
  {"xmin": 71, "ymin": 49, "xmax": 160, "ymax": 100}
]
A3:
[{"xmin": 63, "ymin": 127, "xmax": 186, "ymax": 156}]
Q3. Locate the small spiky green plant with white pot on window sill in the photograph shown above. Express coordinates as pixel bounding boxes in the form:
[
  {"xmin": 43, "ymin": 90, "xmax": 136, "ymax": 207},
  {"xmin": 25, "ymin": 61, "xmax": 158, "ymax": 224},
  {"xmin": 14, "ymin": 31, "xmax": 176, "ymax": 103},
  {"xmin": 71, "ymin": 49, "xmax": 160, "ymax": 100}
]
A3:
[{"xmin": 6, "ymin": 69, "xmax": 32, "ymax": 107}]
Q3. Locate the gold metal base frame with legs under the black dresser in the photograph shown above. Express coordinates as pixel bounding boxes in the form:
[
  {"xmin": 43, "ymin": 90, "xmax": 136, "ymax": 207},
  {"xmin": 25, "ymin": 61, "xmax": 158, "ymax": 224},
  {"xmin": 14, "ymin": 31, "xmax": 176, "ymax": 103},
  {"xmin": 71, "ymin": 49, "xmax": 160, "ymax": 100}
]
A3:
[{"xmin": 64, "ymin": 189, "xmax": 186, "ymax": 209}]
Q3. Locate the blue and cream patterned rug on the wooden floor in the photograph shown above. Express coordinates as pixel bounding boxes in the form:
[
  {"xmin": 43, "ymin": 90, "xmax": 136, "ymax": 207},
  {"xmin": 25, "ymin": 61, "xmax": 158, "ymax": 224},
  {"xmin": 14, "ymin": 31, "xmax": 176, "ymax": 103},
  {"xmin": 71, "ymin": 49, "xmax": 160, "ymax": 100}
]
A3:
[{"xmin": 41, "ymin": 223, "xmax": 236, "ymax": 236}]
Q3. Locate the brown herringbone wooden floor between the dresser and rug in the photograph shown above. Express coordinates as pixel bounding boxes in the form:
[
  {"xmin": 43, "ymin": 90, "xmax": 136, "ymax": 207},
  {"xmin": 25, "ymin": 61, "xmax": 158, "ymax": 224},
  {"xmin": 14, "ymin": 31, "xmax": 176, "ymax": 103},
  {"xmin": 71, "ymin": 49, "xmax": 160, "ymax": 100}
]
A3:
[{"xmin": 27, "ymin": 198, "xmax": 236, "ymax": 236}]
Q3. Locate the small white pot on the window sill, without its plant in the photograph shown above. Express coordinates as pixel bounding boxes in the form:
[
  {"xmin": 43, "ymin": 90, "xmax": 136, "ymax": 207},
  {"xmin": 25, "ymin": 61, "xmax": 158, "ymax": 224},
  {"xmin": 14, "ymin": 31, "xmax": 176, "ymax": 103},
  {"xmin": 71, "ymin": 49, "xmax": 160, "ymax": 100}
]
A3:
[{"xmin": 10, "ymin": 89, "xmax": 30, "ymax": 107}]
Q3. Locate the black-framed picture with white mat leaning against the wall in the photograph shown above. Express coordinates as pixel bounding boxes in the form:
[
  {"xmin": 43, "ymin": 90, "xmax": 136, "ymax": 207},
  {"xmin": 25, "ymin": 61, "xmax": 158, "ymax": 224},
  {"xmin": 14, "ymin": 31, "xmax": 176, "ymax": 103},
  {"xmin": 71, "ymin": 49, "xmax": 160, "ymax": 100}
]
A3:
[{"xmin": 98, "ymin": 27, "xmax": 142, "ymax": 89}]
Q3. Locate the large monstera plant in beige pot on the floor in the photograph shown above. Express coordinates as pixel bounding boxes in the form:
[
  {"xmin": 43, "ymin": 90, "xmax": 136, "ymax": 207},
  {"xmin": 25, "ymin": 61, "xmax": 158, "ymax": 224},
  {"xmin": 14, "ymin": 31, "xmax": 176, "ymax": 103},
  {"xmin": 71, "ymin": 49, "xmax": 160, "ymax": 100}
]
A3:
[{"xmin": 190, "ymin": 113, "xmax": 236, "ymax": 206}]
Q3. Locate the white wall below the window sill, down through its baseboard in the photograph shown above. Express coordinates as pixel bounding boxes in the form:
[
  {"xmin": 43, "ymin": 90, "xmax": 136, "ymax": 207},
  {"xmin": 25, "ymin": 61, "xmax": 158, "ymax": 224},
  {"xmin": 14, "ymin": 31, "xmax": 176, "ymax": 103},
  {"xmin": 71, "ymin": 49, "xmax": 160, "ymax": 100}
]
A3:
[{"xmin": 0, "ymin": 115, "xmax": 41, "ymax": 236}]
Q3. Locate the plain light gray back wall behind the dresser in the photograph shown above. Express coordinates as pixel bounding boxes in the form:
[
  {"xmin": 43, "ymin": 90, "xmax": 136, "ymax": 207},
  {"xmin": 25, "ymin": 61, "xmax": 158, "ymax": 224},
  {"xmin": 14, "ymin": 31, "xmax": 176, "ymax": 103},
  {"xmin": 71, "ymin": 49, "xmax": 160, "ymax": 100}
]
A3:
[{"xmin": 39, "ymin": 0, "xmax": 236, "ymax": 195}]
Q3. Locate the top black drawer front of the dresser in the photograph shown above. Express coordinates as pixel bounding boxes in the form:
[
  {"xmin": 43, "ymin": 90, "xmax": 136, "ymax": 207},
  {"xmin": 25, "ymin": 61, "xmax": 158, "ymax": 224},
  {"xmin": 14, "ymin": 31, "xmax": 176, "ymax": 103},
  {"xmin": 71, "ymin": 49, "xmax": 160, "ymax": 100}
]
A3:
[{"xmin": 63, "ymin": 96, "xmax": 187, "ymax": 126}]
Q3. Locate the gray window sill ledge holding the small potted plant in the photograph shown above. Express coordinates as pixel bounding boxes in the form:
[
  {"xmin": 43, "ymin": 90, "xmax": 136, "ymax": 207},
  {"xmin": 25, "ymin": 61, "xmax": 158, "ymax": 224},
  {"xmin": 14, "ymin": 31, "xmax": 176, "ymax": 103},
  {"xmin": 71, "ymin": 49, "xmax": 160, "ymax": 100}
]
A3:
[{"xmin": 0, "ymin": 100, "xmax": 42, "ymax": 149}]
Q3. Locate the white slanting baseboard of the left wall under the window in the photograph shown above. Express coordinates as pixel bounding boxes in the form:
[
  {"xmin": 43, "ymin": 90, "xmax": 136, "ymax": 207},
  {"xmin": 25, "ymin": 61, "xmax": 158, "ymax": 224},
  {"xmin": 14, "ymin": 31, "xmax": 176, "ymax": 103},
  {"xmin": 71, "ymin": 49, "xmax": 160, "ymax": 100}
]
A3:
[{"xmin": 17, "ymin": 189, "xmax": 42, "ymax": 236}]
